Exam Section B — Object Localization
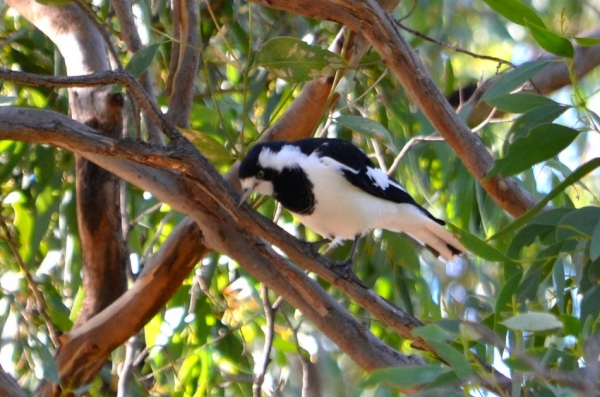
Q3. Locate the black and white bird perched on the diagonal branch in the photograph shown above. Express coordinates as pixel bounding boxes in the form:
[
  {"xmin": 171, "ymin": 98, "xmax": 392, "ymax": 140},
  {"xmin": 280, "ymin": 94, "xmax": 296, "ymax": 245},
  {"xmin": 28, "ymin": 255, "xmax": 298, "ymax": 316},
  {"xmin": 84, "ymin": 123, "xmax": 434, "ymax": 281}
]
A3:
[{"xmin": 239, "ymin": 138, "xmax": 465, "ymax": 260}]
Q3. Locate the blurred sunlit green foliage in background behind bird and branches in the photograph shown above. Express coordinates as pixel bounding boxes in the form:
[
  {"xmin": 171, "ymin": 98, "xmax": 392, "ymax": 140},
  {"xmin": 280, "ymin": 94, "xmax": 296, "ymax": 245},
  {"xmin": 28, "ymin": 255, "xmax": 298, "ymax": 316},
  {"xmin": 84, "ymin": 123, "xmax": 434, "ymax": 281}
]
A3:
[{"xmin": 0, "ymin": 0, "xmax": 600, "ymax": 396}]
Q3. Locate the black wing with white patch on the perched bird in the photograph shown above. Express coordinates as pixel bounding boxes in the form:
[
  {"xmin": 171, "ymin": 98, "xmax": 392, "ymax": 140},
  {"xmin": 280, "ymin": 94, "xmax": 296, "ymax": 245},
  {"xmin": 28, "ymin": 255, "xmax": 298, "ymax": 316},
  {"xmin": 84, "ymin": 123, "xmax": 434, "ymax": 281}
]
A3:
[{"xmin": 296, "ymin": 138, "xmax": 445, "ymax": 225}]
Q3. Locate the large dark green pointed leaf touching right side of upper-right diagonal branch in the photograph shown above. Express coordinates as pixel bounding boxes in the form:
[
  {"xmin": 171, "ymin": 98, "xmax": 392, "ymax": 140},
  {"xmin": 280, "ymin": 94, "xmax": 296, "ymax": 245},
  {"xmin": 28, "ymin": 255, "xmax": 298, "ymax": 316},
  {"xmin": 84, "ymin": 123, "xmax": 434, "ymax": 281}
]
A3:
[{"xmin": 484, "ymin": 124, "xmax": 579, "ymax": 180}]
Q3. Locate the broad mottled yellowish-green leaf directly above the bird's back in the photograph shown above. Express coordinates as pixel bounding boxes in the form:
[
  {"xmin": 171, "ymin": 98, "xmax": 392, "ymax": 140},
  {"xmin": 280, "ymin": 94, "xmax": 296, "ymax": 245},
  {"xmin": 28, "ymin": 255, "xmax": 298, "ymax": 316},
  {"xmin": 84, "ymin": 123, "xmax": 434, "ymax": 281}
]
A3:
[{"xmin": 253, "ymin": 37, "xmax": 348, "ymax": 83}]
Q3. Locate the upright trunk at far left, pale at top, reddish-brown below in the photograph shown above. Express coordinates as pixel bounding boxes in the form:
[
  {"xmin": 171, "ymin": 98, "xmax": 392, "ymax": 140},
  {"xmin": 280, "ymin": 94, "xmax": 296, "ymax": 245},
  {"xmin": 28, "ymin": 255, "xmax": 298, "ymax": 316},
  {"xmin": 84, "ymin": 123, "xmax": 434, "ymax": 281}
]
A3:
[{"xmin": 7, "ymin": 0, "xmax": 127, "ymax": 396}]
